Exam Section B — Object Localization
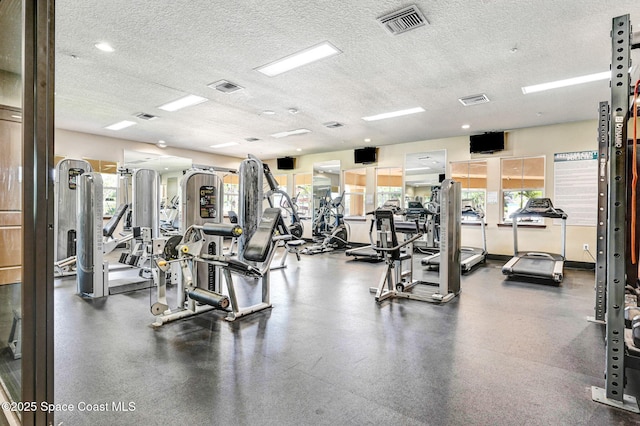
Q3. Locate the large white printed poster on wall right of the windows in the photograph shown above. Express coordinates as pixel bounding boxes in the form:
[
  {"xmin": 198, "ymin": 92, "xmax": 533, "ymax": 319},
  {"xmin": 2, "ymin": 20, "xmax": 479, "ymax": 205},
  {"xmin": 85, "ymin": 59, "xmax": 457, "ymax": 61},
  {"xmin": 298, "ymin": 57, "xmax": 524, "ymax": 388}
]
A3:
[{"xmin": 553, "ymin": 151, "xmax": 598, "ymax": 226}]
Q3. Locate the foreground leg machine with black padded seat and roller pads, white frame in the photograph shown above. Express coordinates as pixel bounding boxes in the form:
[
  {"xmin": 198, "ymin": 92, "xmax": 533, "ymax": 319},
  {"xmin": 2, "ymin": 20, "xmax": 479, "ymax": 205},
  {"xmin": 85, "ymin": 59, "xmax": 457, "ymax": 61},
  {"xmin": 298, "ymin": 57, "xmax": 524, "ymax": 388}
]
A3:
[{"xmin": 151, "ymin": 196, "xmax": 284, "ymax": 326}]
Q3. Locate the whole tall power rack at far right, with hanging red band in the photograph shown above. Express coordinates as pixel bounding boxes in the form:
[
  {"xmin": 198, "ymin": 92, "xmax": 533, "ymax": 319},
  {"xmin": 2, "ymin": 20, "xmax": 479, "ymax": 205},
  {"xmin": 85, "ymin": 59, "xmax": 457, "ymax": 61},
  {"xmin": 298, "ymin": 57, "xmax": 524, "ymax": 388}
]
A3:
[{"xmin": 591, "ymin": 15, "xmax": 640, "ymax": 413}]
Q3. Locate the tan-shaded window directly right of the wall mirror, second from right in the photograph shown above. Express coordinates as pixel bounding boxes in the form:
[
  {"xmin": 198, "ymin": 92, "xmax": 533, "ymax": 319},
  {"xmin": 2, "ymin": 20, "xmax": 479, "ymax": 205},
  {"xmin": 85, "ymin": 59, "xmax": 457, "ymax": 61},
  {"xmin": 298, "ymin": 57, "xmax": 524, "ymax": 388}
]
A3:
[{"xmin": 451, "ymin": 160, "xmax": 487, "ymax": 222}]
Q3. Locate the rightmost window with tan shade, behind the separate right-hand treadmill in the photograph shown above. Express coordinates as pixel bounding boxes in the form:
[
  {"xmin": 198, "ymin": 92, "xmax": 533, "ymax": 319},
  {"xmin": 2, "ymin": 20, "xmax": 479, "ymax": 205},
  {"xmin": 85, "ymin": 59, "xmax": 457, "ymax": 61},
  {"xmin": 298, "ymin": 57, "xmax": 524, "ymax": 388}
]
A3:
[{"xmin": 501, "ymin": 157, "xmax": 545, "ymax": 223}]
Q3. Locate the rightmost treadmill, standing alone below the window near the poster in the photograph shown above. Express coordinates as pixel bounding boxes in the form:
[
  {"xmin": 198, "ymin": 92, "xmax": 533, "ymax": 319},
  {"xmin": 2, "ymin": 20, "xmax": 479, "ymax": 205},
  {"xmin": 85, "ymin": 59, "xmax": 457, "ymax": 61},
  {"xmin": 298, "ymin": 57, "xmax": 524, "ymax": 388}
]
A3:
[{"xmin": 502, "ymin": 198, "xmax": 567, "ymax": 283}]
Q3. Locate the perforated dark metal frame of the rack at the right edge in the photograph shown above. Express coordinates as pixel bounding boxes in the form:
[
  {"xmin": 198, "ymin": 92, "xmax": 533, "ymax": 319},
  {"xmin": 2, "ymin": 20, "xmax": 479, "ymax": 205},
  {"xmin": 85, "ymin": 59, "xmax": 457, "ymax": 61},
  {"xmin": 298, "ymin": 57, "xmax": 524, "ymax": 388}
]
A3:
[{"xmin": 591, "ymin": 15, "xmax": 640, "ymax": 413}]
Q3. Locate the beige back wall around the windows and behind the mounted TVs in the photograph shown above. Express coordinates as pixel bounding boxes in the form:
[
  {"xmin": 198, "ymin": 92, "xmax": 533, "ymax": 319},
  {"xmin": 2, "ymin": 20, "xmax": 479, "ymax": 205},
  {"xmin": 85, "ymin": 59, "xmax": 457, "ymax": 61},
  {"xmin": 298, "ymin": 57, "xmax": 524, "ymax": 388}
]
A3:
[{"xmin": 267, "ymin": 120, "xmax": 597, "ymax": 262}]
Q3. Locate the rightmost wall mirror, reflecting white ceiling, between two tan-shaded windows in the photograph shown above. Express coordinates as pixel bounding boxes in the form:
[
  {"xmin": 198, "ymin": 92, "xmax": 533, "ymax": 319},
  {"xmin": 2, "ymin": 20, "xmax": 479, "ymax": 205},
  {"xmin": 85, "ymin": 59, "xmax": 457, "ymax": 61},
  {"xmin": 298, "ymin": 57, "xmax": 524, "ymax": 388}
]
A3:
[{"xmin": 403, "ymin": 149, "xmax": 447, "ymax": 207}]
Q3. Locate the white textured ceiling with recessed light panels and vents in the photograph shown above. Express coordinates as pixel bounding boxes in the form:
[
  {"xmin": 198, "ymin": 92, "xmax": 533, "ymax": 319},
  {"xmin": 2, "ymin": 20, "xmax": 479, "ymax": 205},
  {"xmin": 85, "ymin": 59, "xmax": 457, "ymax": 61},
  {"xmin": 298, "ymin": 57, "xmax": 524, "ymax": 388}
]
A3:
[{"xmin": 56, "ymin": 0, "xmax": 640, "ymax": 159}]
